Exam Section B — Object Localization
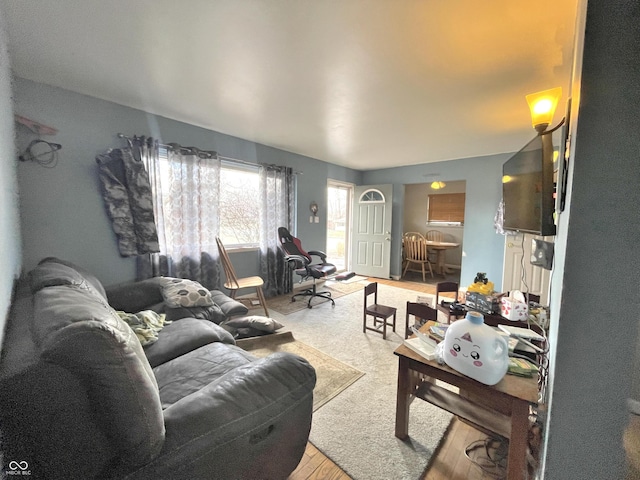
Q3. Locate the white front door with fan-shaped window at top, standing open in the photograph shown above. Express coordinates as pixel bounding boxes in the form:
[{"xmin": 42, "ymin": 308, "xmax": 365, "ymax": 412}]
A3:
[{"xmin": 351, "ymin": 185, "xmax": 393, "ymax": 278}]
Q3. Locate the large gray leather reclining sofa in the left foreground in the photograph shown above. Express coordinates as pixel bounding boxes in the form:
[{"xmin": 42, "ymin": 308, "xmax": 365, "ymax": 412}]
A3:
[{"xmin": 0, "ymin": 258, "xmax": 316, "ymax": 480}]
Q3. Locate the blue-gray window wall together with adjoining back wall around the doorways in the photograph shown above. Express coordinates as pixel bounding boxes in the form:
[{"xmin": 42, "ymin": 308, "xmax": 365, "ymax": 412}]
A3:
[{"xmin": 14, "ymin": 78, "xmax": 509, "ymax": 292}]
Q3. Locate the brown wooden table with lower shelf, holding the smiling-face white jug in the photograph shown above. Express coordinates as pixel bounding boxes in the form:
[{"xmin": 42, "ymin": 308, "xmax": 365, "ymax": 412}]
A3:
[{"xmin": 394, "ymin": 322, "xmax": 538, "ymax": 480}]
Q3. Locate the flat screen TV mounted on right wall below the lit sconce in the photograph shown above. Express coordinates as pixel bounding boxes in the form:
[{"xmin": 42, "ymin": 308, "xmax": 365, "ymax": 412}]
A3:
[{"xmin": 502, "ymin": 134, "xmax": 556, "ymax": 235}]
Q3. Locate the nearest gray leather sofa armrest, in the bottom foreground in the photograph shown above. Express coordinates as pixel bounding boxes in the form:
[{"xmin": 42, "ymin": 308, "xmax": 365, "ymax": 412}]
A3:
[{"xmin": 135, "ymin": 353, "xmax": 316, "ymax": 479}]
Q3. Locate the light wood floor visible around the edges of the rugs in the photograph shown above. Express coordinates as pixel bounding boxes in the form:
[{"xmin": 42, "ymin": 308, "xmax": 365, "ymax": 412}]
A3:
[{"xmin": 289, "ymin": 278, "xmax": 496, "ymax": 480}]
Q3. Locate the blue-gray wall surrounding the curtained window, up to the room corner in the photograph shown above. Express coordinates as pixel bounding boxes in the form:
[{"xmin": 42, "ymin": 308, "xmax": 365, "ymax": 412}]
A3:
[{"xmin": 14, "ymin": 78, "xmax": 361, "ymax": 284}]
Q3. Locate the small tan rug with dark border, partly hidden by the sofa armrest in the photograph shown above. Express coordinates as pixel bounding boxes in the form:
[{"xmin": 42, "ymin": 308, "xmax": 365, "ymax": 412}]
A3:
[{"xmin": 237, "ymin": 332, "xmax": 364, "ymax": 411}]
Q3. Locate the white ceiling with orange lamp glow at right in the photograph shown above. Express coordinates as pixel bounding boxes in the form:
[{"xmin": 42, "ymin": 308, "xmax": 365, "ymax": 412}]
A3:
[{"xmin": 0, "ymin": 0, "xmax": 577, "ymax": 170}]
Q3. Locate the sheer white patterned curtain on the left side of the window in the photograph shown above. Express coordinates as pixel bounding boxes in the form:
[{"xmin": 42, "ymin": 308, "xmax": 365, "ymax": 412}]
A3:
[{"xmin": 143, "ymin": 142, "xmax": 220, "ymax": 288}]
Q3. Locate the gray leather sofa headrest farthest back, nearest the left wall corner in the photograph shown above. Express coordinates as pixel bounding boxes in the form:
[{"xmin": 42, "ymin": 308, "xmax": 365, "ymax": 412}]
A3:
[{"xmin": 29, "ymin": 257, "xmax": 107, "ymax": 298}]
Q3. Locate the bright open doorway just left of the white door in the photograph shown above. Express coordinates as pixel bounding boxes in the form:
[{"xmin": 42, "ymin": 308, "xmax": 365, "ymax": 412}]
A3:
[{"xmin": 326, "ymin": 180, "xmax": 354, "ymax": 272}]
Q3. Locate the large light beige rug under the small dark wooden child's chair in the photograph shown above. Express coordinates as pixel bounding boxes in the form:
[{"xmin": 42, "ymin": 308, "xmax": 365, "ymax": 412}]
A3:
[{"xmin": 248, "ymin": 284, "xmax": 451, "ymax": 480}]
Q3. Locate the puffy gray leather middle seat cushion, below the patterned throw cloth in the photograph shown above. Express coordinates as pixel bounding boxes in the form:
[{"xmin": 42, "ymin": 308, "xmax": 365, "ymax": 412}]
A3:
[{"xmin": 144, "ymin": 318, "xmax": 235, "ymax": 367}]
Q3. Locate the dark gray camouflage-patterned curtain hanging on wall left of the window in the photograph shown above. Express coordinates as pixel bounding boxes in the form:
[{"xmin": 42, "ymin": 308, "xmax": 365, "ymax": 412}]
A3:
[{"xmin": 96, "ymin": 143, "xmax": 159, "ymax": 257}]
